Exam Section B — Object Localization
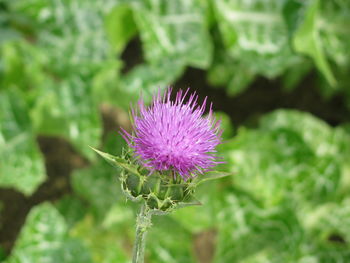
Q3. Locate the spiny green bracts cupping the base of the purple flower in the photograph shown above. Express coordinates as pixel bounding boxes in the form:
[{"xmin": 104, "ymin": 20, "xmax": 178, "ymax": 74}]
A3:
[{"xmin": 92, "ymin": 148, "xmax": 229, "ymax": 213}]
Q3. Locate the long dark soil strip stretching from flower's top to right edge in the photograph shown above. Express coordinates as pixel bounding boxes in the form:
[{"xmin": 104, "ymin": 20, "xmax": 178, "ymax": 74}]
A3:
[{"xmin": 175, "ymin": 68, "xmax": 350, "ymax": 126}]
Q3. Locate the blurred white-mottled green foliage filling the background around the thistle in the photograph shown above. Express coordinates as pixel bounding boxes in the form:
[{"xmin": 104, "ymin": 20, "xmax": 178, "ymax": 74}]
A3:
[{"xmin": 0, "ymin": 0, "xmax": 350, "ymax": 263}]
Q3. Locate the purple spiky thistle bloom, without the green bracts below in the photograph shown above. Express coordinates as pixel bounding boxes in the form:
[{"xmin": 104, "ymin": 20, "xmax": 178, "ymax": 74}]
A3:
[{"xmin": 123, "ymin": 89, "xmax": 222, "ymax": 180}]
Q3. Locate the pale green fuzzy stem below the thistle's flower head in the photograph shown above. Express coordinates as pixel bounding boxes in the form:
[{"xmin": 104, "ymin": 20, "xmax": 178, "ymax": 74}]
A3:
[{"xmin": 132, "ymin": 204, "xmax": 152, "ymax": 263}]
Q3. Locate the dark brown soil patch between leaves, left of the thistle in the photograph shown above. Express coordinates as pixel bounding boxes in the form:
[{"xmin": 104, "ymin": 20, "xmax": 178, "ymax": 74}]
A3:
[{"xmin": 0, "ymin": 136, "xmax": 88, "ymax": 254}]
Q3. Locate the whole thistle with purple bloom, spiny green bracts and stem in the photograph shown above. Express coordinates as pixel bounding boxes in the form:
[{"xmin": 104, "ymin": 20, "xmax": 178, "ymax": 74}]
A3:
[{"xmin": 94, "ymin": 89, "xmax": 228, "ymax": 263}]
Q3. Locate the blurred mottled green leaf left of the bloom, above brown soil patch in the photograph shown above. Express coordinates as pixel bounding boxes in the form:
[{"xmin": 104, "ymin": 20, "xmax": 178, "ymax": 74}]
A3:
[{"xmin": 31, "ymin": 76, "xmax": 102, "ymax": 158}]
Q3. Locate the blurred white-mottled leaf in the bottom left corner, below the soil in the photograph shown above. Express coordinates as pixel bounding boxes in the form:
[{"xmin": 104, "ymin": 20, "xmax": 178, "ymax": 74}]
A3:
[{"xmin": 6, "ymin": 203, "xmax": 92, "ymax": 263}]
